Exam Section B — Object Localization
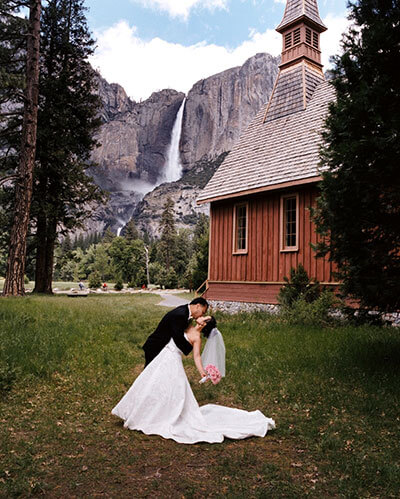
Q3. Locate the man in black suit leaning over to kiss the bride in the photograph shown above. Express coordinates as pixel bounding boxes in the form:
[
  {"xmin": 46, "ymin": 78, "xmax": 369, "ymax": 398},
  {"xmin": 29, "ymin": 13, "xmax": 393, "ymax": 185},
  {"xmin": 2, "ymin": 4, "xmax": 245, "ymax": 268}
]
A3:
[{"xmin": 143, "ymin": 298, "xmax": 208, "ymax": 367}]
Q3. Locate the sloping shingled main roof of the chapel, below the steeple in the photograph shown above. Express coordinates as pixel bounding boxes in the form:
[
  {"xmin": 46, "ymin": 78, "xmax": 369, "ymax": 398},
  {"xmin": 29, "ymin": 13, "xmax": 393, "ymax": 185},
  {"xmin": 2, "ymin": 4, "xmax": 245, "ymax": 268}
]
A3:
[{"xmin": 197, "ymin": 71, "xmax": 335, "ymax": 204}]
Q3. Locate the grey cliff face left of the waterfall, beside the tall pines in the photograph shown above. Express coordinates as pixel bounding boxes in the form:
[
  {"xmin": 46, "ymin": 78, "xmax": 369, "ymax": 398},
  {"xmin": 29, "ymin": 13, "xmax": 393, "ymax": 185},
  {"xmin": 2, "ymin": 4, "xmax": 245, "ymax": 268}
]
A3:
[{"xmin": 92, "ymin": 79, "xmax": 185, "ymax": 193}]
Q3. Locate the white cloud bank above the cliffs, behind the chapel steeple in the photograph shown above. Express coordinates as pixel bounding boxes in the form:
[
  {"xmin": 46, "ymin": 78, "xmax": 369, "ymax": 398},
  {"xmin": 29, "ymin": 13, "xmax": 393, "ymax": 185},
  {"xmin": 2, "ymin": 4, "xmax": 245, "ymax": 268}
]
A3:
[{"xmin": 91, "ymin": 15, "xmax": 348, "ymax": 100}]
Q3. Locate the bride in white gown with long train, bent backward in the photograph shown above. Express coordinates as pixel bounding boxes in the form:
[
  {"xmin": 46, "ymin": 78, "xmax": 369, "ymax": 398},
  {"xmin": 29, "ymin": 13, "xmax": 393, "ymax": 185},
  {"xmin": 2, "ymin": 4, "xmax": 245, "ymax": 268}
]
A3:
[{"xmin": 111, "ymin": 317, "xmax": 275, "ymax": 444}]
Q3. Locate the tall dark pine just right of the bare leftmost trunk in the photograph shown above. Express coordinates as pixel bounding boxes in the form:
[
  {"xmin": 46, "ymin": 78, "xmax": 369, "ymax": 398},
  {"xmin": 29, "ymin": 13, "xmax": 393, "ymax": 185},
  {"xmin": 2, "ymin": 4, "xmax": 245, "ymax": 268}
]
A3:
[{"xmin": 34, "ymin": 0, "xmax": 101, "ymax": 293}]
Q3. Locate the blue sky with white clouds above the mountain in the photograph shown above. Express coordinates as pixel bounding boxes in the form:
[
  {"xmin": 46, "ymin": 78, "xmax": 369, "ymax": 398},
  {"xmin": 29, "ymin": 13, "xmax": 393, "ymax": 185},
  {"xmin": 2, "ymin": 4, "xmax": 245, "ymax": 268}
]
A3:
[{"xmin": 85, "ymin": 0, "xmax": 348, "ymax": 101}]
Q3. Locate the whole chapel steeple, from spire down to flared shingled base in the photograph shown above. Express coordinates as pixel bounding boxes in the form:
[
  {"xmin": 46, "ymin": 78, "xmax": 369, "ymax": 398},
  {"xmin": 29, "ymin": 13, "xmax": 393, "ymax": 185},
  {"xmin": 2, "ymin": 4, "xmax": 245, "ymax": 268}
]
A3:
[{"xmin": 263, "ymin": 0, "xmax": 327, "ymax": 123}]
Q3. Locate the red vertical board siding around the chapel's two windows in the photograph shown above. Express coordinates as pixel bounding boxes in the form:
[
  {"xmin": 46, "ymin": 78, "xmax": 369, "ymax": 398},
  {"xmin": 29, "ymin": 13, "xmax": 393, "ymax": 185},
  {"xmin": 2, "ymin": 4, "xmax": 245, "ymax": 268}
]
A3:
[{"xmin": 209, "ymin": 185, "xmax": 333, "ymax": 292}]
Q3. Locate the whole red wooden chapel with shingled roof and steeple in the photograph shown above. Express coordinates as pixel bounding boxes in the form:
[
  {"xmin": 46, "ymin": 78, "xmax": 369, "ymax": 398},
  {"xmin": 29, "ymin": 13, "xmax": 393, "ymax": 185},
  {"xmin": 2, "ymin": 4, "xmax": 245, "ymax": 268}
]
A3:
[{"xmin": 198, "ymin": 0, "xmax": 335, "ymax": 304}]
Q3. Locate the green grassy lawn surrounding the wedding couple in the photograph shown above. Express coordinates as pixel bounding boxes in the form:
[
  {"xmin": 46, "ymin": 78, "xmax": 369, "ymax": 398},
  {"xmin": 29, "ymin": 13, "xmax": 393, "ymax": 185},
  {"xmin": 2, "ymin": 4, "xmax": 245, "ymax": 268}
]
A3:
[{"xmin": 0, "ymin": 295, "xmax": 400, "ymax": 499}]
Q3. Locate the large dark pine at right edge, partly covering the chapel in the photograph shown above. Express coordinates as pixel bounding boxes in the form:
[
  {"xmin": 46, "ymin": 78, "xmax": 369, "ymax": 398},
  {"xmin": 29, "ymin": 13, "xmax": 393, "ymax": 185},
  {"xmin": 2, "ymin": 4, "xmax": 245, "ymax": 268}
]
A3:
[{"xmin": 315, "ymin": 0, "xmax": 400, "ymax": 311}]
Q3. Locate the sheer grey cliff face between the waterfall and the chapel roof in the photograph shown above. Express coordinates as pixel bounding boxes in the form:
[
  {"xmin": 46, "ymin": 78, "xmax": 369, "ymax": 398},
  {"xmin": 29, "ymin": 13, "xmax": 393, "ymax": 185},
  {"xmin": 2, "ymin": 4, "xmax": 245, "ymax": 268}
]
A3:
[{"xmin": 181, "ymin": 54, "xmax": 279, "ymax": 169}]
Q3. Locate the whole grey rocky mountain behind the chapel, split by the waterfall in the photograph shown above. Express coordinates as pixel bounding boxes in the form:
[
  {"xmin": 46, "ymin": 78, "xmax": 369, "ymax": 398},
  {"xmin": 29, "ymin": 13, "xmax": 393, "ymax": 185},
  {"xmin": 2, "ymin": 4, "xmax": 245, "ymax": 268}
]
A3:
[{"xmin": 89, "ymin": 54, "xmax": 279, "ymax": 236}]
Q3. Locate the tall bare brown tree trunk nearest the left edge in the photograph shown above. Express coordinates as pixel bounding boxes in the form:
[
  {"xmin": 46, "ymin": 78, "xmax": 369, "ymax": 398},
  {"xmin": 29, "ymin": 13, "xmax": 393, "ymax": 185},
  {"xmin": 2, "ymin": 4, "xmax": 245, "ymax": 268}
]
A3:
[{"xmin": 3, "ymin": 0, "xmax": 42, "ymax": 296}]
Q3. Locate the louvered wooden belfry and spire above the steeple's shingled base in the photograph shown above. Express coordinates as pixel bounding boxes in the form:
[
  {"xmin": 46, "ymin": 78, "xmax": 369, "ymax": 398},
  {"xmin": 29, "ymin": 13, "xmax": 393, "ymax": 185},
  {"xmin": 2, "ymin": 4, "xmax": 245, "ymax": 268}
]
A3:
[{"xmin": 276, "ymin": 0, "xmax": 327, "ymax": 68}]
